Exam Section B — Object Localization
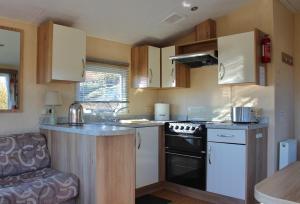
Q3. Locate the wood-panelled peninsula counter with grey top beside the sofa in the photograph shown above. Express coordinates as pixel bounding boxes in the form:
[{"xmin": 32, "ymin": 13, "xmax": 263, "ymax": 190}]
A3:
[{"xmin": 40, "ymin": 124, "xmax": 135, "ymax": 204}]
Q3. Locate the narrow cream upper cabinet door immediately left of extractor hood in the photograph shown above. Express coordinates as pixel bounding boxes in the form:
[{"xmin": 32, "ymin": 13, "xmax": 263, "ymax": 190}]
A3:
[{"xmin": 161, "ymin": 46, "xmax": 176, "ymax": 88}]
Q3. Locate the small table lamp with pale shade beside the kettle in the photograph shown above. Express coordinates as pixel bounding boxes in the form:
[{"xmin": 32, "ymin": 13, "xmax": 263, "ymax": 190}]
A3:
[{"xmin": 45, "ymin": 91, "xmax": 62, "ymax": 125}]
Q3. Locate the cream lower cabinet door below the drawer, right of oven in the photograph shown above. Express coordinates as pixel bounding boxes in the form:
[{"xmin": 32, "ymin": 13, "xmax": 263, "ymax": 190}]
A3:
[{"xmin": 206, "ymin": 142, "xmax": 246, "ymax": 200}]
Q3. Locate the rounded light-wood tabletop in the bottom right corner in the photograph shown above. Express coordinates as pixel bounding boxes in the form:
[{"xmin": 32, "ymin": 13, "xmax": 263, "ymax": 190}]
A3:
[{"xmin": 255, "ymin": 161, "xmax": 300, "ymax": 204}]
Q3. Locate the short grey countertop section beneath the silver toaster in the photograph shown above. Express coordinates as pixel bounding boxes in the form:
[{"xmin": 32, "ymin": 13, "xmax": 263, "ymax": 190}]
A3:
[{"xmin": 206, "ymin": 122, "xmax": 268, "ymax": 130}]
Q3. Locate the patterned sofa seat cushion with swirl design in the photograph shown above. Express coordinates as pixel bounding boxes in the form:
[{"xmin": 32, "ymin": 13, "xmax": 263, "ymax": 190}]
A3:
[{"xmin": 0, "ymin": 168, "xmax": 79, "ymax": 204}]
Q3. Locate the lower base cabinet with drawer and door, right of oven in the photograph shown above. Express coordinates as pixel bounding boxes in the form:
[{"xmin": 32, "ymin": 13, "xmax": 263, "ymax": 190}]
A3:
[{"xmin": 206, "ymin": 128, "xmax": 268, "ymax": 204}]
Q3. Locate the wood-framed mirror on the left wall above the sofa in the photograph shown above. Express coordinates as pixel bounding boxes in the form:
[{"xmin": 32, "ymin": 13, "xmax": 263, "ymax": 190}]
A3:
[{"xmin": 0, "ymin": 26, "xmax": 23, "ymax": 112}]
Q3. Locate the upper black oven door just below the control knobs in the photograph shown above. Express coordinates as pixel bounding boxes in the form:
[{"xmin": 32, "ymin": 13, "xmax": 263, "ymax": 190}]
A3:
[{"xmin": 165, "ymin": 134, "xmax": 206, "ymax": 155}]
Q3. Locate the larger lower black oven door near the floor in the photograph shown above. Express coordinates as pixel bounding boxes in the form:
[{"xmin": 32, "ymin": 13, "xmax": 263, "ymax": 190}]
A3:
[{"xmin": 166, "ymin": 152, "xmax": 206, "ymax": 191}]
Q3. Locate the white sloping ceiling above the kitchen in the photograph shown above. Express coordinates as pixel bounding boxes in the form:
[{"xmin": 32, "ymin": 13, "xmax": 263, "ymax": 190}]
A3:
[{"xmin": 0, "ymin": 0, "xmax": 250, "ymax": 44}]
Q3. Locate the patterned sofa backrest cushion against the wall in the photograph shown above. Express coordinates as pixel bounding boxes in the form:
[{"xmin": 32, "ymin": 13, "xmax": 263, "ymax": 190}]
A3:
[{"xmin": 0, "ymin": 133, "xmax": 50, "ymax": 177}]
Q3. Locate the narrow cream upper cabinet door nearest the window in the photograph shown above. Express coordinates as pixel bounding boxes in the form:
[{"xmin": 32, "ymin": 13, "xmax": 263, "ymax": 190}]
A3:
[{"xmin": 148, "ymin": 46, "xmax": 160, "ymax": 88}]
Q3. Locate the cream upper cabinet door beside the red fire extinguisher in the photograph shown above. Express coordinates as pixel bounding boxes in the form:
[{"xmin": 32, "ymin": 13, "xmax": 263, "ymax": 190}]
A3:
[{"xmin": 218, "ymin": 31, "xmax": 257, "ymax": 84}]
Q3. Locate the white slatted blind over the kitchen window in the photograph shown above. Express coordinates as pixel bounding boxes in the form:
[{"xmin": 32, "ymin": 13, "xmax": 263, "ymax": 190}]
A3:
[{"xmin": 76, "ymin": 63, "xmax": 128, "ymax": 103}]
